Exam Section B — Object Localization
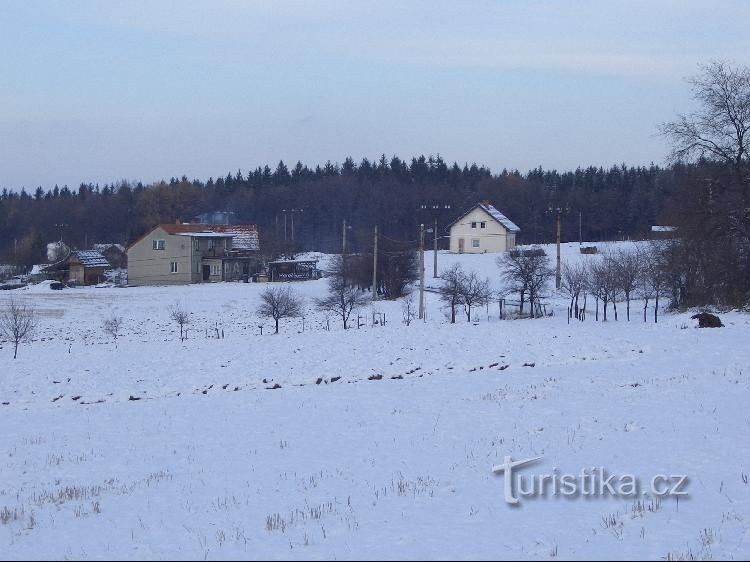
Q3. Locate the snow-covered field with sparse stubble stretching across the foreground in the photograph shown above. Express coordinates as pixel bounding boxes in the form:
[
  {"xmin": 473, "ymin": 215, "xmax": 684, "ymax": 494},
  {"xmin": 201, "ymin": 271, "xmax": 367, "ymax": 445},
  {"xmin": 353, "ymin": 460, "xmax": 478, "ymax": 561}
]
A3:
[{"xmin": 0, "ymin": 244, "xmax": 750, "ymax": 560}]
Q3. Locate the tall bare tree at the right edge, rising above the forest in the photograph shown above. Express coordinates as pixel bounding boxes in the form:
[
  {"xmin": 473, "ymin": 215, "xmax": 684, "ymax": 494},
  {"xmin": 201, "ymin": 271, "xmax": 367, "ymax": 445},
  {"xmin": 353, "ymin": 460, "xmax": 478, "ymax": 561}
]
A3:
[{"xmin": 661, "ymin": 61, "xmax": 750, "ymax": 307}]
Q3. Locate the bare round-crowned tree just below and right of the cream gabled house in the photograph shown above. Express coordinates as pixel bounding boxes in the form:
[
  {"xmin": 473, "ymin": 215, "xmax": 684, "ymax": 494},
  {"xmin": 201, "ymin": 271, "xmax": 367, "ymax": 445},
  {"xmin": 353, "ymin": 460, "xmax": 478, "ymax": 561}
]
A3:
[{"xmin": 496, "ymin": 248, "xmax": 555, "ymax": 316}]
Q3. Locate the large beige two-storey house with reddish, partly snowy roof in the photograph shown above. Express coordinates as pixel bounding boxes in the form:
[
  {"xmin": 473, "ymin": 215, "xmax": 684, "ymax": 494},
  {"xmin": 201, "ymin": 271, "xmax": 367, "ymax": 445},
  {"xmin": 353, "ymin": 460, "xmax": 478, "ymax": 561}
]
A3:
[{"xmin": 128, "ymin": 223, "xmax": 260, "ymax": 286}]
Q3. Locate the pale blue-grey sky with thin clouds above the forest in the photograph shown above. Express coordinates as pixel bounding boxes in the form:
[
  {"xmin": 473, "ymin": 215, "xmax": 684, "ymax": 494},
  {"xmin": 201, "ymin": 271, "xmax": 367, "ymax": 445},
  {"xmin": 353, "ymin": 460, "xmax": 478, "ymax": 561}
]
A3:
[{"xmin": 0, "ymin": 0, "xmax": 750, "ymax": 189}]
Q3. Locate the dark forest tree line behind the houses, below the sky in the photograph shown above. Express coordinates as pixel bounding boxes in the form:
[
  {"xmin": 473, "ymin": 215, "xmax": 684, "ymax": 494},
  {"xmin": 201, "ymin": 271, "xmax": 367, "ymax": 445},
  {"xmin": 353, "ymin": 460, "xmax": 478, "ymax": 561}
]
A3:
[{"xmin": 0, "ymin": 156, "xmax": 691, "ymax": 266}]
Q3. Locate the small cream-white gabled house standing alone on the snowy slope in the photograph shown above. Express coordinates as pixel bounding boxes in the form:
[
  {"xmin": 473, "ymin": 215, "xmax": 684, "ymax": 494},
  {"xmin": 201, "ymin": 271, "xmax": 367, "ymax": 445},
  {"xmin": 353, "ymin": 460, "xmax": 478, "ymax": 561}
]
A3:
[{"xmin": 450, "ymin": 201, "xmax": 521, "ymax": 254}]
